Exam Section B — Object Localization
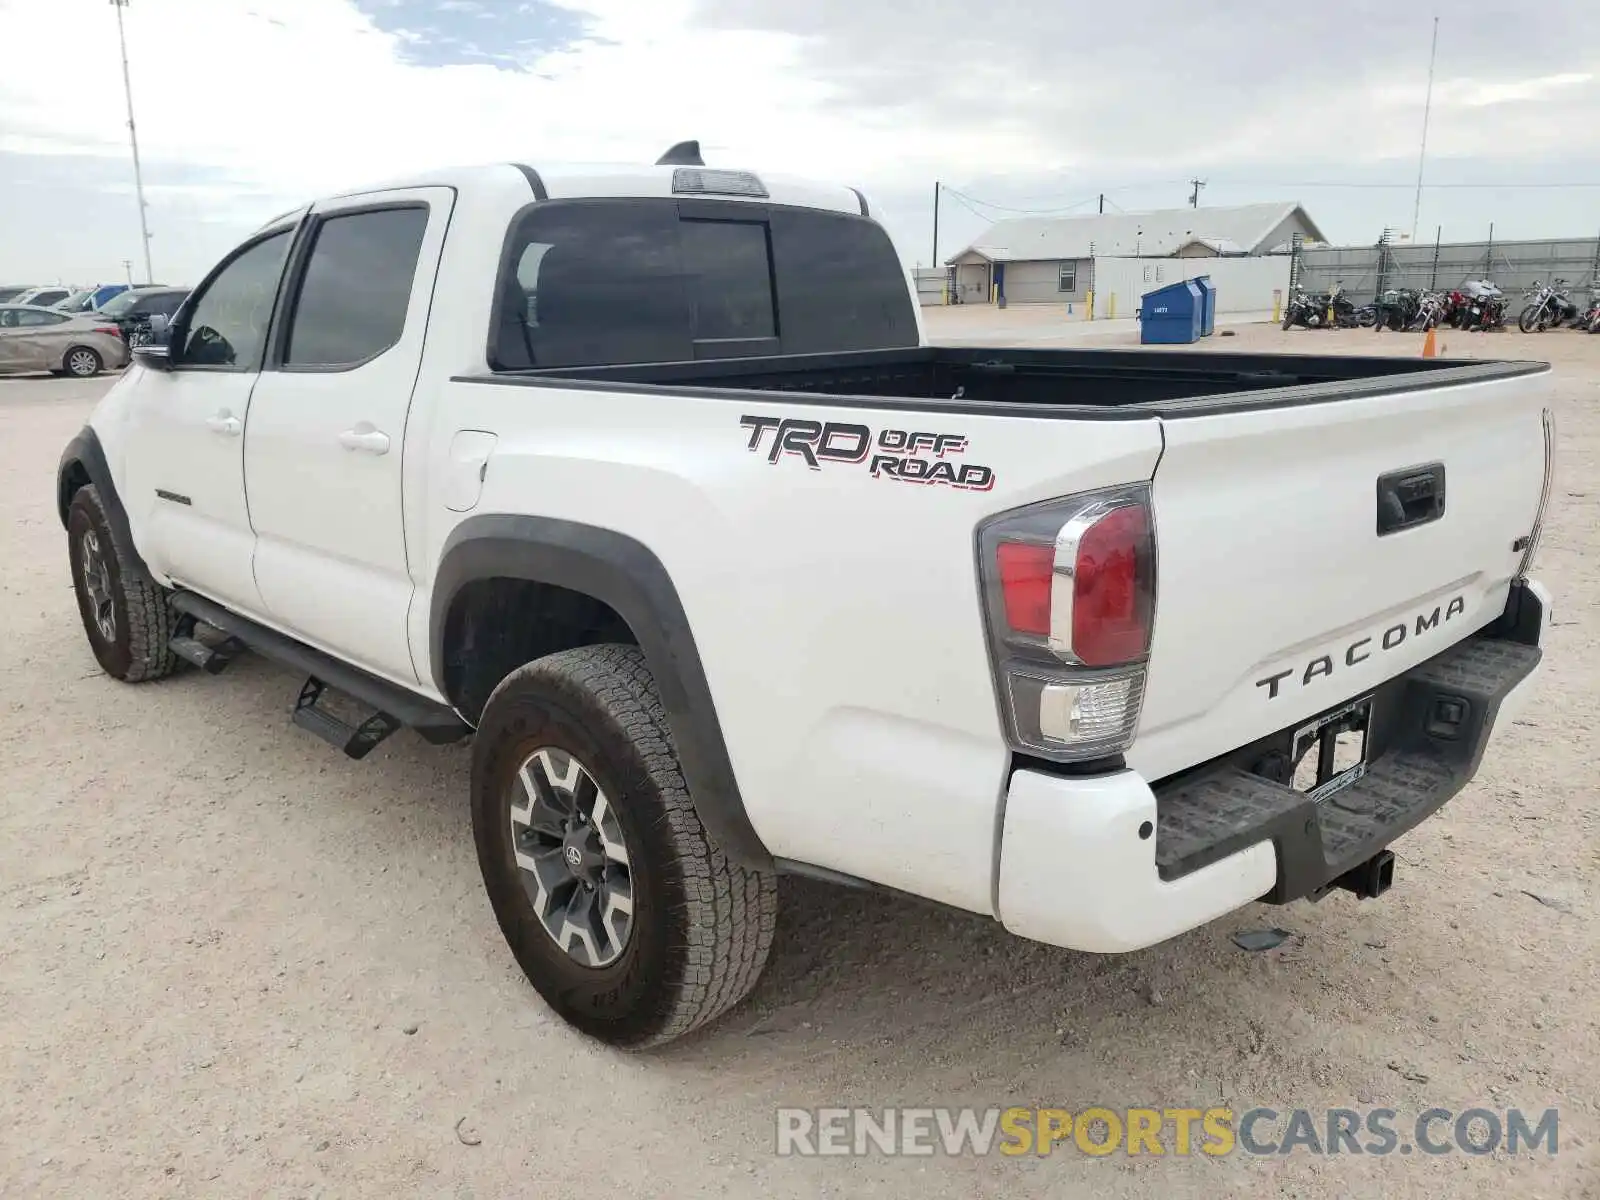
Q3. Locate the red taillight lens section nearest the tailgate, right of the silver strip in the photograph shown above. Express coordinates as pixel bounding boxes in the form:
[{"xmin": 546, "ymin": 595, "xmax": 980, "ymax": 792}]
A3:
[{"xmin": 1072, "ymin": 504, "xmax": 1152, "ymax": 667}]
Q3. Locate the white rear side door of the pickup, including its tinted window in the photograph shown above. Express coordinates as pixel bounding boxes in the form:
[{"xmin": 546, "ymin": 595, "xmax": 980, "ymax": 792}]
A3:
[{"xmin": 245, "ymin": 187, "xmax": 454, "ymax": 685}]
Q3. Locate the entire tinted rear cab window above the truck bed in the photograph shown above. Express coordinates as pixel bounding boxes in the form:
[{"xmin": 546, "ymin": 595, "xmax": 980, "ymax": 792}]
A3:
[{"xmin": 490, "ymin": 198, "xmax": 918, "ymax": 371}]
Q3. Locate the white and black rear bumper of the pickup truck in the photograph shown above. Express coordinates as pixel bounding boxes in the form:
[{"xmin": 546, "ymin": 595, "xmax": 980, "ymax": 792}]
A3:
[{"xmin": 998, "ymin": 582, "xmax": 1550, "ymax": 952}]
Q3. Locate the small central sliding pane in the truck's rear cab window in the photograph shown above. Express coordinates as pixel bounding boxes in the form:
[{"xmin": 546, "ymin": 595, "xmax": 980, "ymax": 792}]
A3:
[{"xmin": 678, "ymin": 221, "xmax": 778, "ymax": 341}]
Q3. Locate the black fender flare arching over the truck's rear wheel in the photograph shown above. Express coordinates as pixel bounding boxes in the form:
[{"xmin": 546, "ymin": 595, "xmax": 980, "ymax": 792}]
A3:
[{"xmin": 429, "ymin": 514, "xmax": 773, "ymax": 870}]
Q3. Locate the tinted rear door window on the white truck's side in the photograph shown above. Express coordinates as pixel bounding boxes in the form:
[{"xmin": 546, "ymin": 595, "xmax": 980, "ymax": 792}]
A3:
[{"xmin": 283, "ymin": 208, "xmax": 427, "ymax": 366}]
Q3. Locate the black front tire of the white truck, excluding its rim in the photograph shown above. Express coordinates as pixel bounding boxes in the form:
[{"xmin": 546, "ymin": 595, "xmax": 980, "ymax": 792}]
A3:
[{"xmin": 67, "ymin": 483, "xmax": 179, "ymax": 683}]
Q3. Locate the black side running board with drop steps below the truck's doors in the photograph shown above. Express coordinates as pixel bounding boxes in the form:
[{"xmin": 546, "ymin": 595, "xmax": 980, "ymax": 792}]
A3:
[{"xmin": 171, "ymin": 592, "xmax": 472, "ymax": 758}]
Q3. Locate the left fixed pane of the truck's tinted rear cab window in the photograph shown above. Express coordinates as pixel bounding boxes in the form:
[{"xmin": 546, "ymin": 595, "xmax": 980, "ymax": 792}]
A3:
[{"xmin": 491, "ymin": 200, "xmax": 694, "ymax": 371}]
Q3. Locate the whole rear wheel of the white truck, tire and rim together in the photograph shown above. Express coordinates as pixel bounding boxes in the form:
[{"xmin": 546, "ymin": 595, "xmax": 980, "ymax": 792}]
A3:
[{"xmin": 472, "ymin": 645, "xmax": 778, "ymax": 1046}]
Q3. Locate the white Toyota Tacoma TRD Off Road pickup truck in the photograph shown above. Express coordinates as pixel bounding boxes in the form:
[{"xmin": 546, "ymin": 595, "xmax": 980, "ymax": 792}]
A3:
[{"xmin": 58, "ymin": 144, "xmax": 1552, "ymax": 1045}]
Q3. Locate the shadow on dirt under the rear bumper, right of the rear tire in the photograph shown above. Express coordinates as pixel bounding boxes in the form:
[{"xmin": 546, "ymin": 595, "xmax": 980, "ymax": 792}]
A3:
[{"xmin": 658, "ymin": 878, "xmax": 1320, "ymax": 1081}]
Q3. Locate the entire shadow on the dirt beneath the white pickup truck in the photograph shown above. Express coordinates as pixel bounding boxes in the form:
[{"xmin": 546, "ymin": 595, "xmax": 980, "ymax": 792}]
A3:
[{"xmin": 168, "ymin": 656, "xmax": 1369, "ymax": 1102}]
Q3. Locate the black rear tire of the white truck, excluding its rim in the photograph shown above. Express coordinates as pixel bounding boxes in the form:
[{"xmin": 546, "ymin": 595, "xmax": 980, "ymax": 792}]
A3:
[{"xmin": 472, "ymin": 645, "xmax": 778, "ymax": 1046}]
